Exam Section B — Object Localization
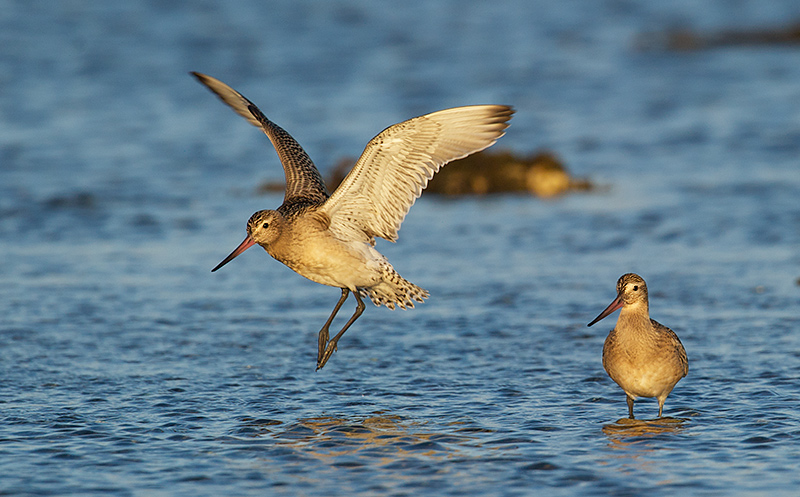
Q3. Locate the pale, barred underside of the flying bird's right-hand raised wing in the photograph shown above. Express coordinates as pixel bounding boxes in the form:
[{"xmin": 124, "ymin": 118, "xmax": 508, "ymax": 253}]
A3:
[{"xmin": 320, "ymin": 105, "xmax": 514, "ymax": 241}]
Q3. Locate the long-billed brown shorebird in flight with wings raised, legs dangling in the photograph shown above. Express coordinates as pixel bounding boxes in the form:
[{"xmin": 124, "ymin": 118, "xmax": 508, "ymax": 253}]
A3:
[{"xmin": 192, "ymin": 72, "xmax": 514, "ymax": 370}]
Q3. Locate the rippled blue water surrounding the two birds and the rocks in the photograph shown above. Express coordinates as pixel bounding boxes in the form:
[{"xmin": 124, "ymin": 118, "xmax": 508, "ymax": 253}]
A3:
[{"xmin": 0, "ymin": 0, "xmax": 800, "ymax": 497}]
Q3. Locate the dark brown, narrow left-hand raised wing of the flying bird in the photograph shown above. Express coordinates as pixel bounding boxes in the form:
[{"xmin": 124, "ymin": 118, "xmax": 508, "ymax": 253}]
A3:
[{"xmin": 192, "ymin": 72, "xmax": 328, "ymax": 205}]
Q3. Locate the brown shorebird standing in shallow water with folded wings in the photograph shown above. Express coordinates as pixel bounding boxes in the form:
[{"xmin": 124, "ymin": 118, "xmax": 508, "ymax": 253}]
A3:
[{"xmin": 589, "ymin": 273, "xmax": 689, "ymax": 419}]
